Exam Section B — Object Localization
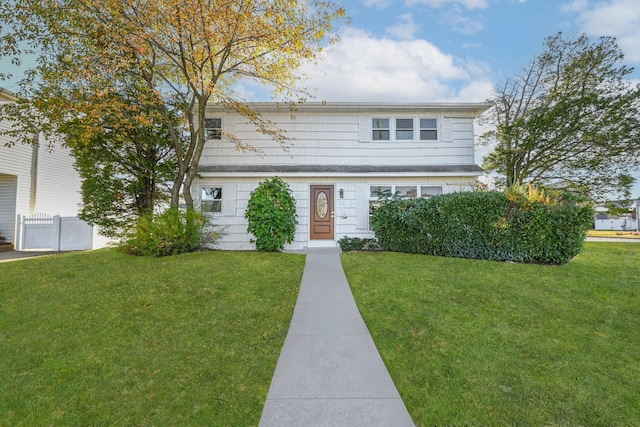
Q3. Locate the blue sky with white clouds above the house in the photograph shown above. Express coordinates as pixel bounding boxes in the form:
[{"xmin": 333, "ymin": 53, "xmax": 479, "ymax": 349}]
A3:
[{"xmin": 2, "ymin": 0, "xmax": 640, "ymax": 197}]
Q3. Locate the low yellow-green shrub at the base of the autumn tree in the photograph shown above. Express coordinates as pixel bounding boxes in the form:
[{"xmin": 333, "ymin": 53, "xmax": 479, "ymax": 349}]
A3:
[{"xmin": 120, "ymin": 208, "xmax": 220, "ymax": 257}]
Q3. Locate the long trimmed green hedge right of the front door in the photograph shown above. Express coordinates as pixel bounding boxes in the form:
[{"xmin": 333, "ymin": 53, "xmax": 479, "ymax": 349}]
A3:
[{"xmin": 371, "ymin": 189, "xmax": 593, "ymax": 264}]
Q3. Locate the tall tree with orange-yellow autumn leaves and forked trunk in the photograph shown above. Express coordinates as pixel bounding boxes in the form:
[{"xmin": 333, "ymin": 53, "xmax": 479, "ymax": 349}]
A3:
[{"xmin": 0, "ymin": 0, "xmax": 344, "ymax": 208}]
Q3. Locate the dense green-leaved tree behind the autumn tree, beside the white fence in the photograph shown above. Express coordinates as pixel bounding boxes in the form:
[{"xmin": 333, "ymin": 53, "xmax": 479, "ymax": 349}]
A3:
[{"xmin": 66, "ymin": 82, "xmax": 176, "ymax": 237}]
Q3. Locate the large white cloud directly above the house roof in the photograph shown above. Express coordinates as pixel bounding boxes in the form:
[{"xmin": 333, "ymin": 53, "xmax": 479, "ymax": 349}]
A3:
[{"xmin": 302, "ymin": 28, "xmax": 492, "ymax": 102}]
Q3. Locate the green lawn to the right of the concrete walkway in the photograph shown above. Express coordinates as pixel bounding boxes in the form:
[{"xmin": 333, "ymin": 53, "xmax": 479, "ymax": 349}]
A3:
[{"xmin": 342, "ymin": 242, "xmax": 640, "ymax": 426}]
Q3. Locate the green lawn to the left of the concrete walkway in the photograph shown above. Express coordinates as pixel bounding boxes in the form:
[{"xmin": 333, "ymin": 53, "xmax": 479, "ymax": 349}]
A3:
[{"xmin": 0, "ymin": 250, "xmax": 304, "ymax": 426}]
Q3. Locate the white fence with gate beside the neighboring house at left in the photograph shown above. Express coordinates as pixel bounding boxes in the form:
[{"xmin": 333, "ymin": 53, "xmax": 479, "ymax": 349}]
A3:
[{"xmin": 16, "ymin": 214, "xmax": 93, "ymax": 251}]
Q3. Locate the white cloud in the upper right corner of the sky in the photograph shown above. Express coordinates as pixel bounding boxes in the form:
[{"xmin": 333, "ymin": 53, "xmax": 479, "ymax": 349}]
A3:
[{"xmin": 574, "ymin": 0, "xmax": 640, "ymax": 63}]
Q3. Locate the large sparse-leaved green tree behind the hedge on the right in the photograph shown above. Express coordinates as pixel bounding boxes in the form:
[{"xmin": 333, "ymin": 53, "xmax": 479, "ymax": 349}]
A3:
[{"xmin": 482, "ymin": 33, "xmax": 640, "ymax": 198}]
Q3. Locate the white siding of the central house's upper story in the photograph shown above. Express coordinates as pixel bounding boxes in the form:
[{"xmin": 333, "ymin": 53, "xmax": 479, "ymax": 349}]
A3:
[{"xmin": 200, "ymin": 114, "xmax": 474, "ymax": 166}]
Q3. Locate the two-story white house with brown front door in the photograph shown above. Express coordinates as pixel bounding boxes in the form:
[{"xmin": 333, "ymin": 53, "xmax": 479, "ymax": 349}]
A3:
[{"xmin": 192, "ymin": 103, "xmax": 490, "ymax": 250}]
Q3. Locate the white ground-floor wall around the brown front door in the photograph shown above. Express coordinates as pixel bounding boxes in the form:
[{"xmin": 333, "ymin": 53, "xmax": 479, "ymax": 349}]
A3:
[{"xmin": 193, "ymin": 177, "xmax": 474, "ymax": 250}]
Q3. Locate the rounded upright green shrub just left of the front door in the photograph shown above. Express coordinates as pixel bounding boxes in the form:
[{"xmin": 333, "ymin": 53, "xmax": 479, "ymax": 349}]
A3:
[{"xmin": 244, "ymin": 177, "xmax": 298, "ymax": 251}]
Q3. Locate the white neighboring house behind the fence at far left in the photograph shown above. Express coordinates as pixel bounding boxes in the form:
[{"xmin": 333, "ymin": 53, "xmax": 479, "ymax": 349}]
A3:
[{"xmin": 0, "ymin": 88, "xmax": 97, "ymax": 251}]
